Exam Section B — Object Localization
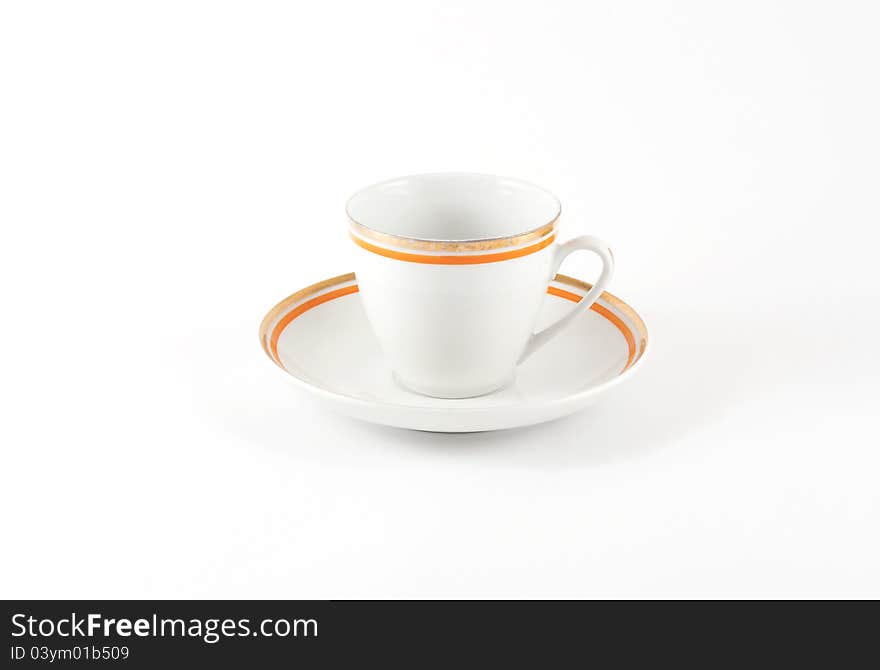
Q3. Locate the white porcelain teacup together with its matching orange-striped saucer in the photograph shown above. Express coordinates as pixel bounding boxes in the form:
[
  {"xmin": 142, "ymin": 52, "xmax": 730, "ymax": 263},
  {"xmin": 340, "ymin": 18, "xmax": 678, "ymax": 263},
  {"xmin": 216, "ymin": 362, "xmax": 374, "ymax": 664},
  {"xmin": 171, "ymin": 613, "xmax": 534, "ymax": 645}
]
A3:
[{"xmin": 260, "ymin": 173, "xmax": 648, "ymax": 432}]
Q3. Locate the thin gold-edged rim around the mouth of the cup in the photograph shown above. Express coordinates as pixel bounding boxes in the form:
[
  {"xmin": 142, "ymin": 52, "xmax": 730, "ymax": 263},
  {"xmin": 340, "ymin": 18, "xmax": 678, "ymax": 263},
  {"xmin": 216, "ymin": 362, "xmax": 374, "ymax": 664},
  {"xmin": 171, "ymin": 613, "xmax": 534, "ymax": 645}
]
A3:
[{"xmin": 345, "ymin": 172, "xmax": 562, "ymax": 250}]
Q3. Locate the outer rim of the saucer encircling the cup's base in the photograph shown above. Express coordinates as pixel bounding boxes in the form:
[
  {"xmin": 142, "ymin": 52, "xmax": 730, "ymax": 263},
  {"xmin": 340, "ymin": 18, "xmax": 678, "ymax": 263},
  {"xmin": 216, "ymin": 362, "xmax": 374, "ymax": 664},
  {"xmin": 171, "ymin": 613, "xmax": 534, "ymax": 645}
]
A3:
[{"xmin": 259, "ymin": 272, "xmax": 651, "ymax": 416}]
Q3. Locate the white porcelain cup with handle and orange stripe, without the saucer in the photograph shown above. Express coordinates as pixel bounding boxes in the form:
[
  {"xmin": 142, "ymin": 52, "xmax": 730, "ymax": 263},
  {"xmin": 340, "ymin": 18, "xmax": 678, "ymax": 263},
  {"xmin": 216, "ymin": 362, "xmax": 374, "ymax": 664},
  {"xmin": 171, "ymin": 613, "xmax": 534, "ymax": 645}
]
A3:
[{"xmin": 346, "ymin": 173, "xmax": 614, "ymax": 398}]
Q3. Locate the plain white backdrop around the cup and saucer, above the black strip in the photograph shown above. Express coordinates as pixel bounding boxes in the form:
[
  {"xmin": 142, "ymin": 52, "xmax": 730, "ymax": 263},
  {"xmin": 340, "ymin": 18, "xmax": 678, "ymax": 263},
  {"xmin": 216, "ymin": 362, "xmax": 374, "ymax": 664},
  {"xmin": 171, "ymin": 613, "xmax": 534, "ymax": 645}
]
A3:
[{"xmin": 0, "ymin": 0, "xmax": 880, "ymax": 598}]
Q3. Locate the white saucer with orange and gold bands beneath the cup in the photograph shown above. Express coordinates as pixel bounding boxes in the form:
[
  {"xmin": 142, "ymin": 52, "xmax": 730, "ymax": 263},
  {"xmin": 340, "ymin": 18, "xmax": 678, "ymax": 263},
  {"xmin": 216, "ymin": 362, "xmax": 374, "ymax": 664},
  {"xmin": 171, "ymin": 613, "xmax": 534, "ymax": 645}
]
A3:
[{"xmin": 260, "ymin": 274, "xmax": 648, "ymax": 432}]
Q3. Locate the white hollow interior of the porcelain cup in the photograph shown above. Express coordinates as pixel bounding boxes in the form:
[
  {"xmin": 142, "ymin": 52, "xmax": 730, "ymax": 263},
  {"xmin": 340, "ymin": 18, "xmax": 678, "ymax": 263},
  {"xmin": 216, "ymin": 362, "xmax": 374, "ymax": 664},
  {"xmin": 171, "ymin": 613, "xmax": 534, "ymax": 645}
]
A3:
[{"xmin": 346, "ymin": 173, "xmax": 560, "ymax": 242}]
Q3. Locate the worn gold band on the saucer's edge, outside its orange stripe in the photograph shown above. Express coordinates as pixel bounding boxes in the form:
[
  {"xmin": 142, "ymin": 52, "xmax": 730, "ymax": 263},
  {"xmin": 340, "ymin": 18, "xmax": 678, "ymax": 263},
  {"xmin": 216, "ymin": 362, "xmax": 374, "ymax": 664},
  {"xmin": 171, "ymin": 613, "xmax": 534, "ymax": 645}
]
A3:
[{"xmin": 260, "ymin": 272, "xmax": 648, "ymax": 374}]
